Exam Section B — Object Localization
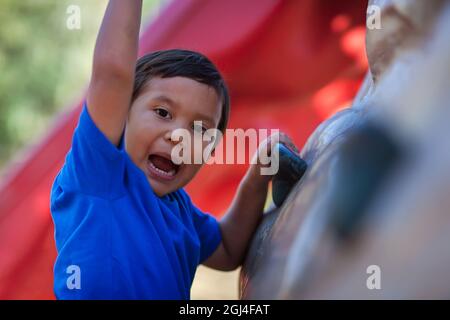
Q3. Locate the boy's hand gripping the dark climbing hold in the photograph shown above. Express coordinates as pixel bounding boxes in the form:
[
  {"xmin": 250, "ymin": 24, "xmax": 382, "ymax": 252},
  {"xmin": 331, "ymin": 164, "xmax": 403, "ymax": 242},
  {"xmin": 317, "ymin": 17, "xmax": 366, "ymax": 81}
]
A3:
[{"xmin": 247, "ymin": 132, "xmax": 299, "ymax": 186}]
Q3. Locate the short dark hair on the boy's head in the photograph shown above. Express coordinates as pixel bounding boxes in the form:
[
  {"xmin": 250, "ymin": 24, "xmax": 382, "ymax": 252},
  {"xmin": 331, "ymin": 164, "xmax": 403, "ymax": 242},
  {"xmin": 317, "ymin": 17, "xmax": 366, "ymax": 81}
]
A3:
[{"xmin": 133, "ymin": 49, "xmax": 230, "ymax": 132}]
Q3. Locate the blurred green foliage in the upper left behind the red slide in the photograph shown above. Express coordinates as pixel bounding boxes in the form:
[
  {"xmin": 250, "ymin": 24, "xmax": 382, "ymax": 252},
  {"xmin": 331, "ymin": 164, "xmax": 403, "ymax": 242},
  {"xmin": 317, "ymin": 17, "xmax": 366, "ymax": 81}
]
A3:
[{"xmin": 0, "ymin": 0, "xmax": 164, "ymax": 171}]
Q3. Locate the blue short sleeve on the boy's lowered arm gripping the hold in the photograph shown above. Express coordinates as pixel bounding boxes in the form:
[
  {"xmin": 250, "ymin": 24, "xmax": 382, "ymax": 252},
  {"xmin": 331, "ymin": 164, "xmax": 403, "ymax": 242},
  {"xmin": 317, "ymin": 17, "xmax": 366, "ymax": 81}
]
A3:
[{"xmin": 186, "ymin": 202, "xmax": 222, "ymax": 264}]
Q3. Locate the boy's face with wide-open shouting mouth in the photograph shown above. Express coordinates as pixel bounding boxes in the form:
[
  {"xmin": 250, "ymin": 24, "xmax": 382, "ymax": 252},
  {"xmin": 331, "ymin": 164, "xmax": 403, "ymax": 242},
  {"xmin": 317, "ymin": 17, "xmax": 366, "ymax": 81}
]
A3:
[{"xmin": 125, "ymin": 77, "xmax": 222, "ymax": 197}]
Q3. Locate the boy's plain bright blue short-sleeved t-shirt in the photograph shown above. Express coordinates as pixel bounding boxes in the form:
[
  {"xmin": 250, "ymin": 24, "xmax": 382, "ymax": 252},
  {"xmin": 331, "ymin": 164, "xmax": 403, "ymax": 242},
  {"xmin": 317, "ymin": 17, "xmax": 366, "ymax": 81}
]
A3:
[{"xmin": 50, "ymin": 105, "xmax": 221, "ymax": 299}]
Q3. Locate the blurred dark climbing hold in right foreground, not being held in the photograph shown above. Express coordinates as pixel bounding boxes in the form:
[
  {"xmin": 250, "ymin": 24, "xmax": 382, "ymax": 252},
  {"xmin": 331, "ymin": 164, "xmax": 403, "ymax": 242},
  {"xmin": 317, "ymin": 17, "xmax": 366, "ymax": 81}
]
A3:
[{"xmin": 331, "ymin": 123, "xmax": 401, "ymax": 239}]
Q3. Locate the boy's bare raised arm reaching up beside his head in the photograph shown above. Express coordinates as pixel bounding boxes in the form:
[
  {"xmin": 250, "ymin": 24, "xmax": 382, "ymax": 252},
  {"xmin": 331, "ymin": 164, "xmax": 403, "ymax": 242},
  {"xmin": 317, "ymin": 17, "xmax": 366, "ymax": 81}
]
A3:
[{"xmin": 87, "ymin": 0, "xmax": 142, "ymax": 145}]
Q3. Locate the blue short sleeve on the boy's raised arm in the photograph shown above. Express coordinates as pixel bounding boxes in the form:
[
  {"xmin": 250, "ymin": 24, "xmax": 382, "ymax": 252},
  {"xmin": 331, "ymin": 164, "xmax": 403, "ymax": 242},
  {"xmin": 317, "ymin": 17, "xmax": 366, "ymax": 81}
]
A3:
[{"xmin": 56, "ymin": 104, "xmax": 125, "ymax": 199}]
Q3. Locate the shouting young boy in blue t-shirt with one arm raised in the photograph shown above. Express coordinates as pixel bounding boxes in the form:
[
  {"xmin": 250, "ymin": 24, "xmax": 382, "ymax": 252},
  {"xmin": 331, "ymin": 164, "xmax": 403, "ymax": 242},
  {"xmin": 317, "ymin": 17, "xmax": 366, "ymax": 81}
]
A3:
[{"xmin": 51, "ymin": 0, "xmax": 295, "ymax": 299}]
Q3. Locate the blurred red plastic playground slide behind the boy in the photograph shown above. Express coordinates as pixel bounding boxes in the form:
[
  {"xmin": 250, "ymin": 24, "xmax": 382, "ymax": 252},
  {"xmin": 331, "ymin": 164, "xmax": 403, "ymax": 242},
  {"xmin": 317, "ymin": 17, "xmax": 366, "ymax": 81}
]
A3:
[{"xmin": 0, "ymin": 0, "xmax": 367, "ymax": 299}]
